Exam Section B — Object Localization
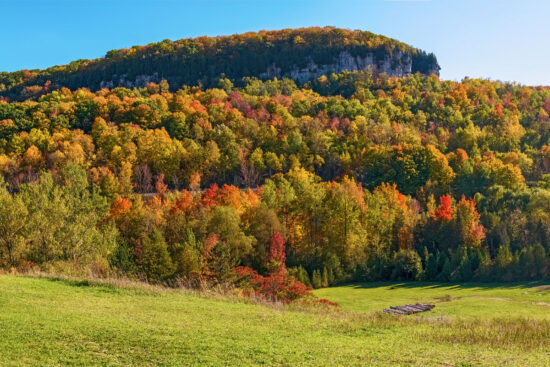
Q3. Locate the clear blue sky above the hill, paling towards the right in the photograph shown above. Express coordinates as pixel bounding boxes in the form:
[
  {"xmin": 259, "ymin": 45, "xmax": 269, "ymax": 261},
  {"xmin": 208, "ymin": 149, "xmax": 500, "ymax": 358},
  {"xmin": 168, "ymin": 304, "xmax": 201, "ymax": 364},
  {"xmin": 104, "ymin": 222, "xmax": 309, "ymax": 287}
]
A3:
[{"xmin": 0, "ymin": 0, "xmax": 550, "ymax": 85}]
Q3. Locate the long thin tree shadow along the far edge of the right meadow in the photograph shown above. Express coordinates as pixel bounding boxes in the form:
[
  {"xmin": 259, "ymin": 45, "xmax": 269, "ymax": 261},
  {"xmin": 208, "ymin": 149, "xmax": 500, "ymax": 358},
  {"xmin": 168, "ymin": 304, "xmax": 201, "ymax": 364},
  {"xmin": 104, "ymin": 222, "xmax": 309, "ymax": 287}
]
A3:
[{"xmin": 340, "ymin": 281, "xmax": 550, "ymax": 289}]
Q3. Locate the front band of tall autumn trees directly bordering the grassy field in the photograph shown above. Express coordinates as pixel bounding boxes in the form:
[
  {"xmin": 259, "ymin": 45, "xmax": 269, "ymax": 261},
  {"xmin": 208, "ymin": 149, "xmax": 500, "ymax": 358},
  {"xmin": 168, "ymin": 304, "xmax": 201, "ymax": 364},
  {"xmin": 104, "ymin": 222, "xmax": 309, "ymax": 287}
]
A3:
[{"xmin": 0, "ymin": 164, "xmax": 550, "ymax": 292}]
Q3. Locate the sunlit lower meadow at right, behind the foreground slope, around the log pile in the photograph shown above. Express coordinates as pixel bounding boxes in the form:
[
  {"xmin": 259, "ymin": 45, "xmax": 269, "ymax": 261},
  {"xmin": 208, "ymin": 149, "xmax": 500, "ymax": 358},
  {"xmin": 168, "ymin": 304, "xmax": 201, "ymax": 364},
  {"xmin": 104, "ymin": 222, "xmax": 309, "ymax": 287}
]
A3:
[{"xmin": 315, "ymin": 282, "xmax": 550, "ymax": 320}]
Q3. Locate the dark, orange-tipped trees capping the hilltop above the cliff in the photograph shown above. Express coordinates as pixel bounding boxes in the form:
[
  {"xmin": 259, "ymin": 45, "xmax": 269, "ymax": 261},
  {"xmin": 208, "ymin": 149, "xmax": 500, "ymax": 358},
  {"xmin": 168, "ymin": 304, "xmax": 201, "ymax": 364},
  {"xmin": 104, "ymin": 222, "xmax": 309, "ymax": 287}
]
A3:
[{"xmin": 0, "ymin": 27, "xmax": 439, "ymax": 100}]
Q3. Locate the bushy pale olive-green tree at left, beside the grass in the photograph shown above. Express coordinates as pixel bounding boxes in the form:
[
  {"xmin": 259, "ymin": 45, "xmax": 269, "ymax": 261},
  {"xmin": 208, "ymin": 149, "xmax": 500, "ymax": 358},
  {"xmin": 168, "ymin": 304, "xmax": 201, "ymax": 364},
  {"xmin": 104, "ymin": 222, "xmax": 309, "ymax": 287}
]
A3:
[{"xmin": 21, "ymin": 165, "xmax": 118, "ymax": 267}]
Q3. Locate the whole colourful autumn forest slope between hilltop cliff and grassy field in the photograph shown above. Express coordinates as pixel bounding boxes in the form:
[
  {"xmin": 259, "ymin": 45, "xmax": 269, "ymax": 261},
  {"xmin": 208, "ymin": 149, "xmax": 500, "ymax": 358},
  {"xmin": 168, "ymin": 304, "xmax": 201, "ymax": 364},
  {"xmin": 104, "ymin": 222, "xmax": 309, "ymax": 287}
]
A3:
[{"xmin": 0, "ymin": 26, "xmax": 550, "ymax": 299}]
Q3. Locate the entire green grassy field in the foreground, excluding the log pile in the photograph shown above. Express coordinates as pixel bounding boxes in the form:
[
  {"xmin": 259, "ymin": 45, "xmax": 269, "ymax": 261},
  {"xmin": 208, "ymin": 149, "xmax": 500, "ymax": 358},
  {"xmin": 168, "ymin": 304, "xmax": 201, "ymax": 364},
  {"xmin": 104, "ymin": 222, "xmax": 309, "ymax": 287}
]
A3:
[{"xmin": 0, "ymin": 275, "xmax": 550, "ymax": 366}]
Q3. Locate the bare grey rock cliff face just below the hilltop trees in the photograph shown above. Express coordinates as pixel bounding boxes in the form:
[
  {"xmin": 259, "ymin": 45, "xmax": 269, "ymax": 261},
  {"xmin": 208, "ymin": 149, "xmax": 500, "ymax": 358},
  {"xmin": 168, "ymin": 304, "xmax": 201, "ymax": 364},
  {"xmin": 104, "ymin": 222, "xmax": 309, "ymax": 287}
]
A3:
[{"xmin": 260, "ymin": 51, "xmax": 426, "ymax": 83}]
